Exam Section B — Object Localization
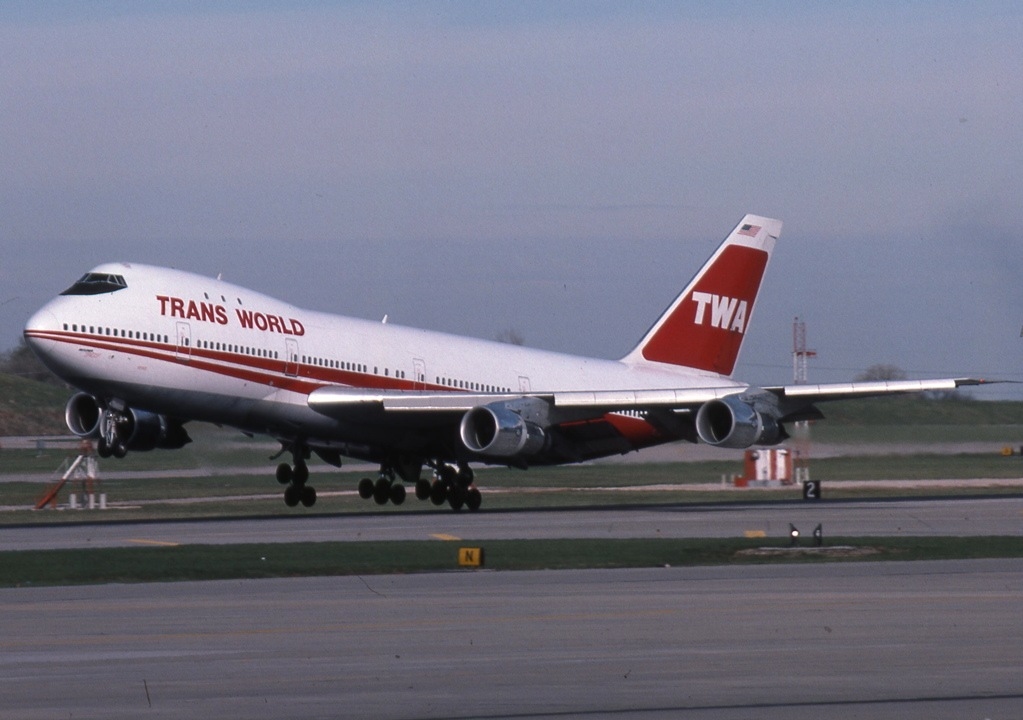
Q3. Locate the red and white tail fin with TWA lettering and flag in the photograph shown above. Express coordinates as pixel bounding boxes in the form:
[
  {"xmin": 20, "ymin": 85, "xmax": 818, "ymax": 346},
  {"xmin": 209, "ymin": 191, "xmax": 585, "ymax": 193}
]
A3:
[{"xmin": 624, "ymin": 215, "xmax": 782, "ymax": 375}]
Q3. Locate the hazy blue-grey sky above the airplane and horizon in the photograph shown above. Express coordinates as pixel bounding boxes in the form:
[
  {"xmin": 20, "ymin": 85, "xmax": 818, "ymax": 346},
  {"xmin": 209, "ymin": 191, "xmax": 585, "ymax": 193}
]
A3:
[{"xmin": 6, "ymin": 0, "xmax": 1023, "ymax": 399}]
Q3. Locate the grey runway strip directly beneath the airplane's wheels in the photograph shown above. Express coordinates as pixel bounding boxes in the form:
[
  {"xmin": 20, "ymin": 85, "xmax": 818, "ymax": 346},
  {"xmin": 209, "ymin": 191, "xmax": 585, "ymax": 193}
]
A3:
[{"xmin": 0, "ymin": 497, "xmax": 1023, "ymax": 550}]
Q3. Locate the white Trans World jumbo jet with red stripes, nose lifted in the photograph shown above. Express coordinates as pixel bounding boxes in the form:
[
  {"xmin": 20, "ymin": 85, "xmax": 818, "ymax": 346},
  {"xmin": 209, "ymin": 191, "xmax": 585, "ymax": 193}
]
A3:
[{"xmin": 25, "ymin": 215, "xmax": 985, "ymax": 510}]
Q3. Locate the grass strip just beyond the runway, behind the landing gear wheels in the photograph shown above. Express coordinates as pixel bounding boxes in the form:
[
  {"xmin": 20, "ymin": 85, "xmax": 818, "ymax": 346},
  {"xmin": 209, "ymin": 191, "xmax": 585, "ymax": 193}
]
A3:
[{"xmin": 0, "ymin": 456, "xmax": 1023, "ymax": 525}]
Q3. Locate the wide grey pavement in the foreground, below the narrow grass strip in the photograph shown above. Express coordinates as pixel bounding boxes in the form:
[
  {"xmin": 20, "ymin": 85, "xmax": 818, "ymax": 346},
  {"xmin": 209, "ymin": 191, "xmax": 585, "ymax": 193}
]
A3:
[{"xmin": 0, "ymin": 560, "xmax": 1023, "ymax": 720}]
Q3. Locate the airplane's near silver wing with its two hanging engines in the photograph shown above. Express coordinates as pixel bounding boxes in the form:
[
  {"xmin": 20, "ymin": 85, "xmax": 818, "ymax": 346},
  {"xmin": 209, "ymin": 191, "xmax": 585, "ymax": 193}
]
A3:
[{"xmin": 307, "ymin": 377, "xmax": 998, "ymax": 464}]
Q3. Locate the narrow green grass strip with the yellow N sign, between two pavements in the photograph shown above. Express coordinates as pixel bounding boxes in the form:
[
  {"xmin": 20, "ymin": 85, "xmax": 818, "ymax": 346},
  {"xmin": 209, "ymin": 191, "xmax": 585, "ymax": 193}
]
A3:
[{"xmin": 0, "ymin": 537, "xmax": 1023, "ymax": 587}]
